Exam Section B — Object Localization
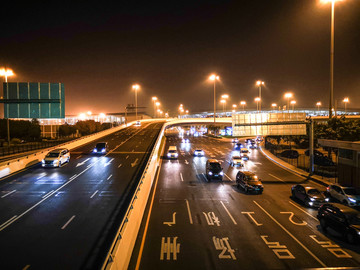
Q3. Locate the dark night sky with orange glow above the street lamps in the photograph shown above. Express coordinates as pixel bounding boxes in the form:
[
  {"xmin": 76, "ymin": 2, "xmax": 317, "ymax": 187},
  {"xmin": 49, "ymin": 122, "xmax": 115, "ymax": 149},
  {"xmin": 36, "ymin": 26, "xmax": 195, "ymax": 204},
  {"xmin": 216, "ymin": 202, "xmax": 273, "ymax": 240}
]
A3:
[{"xmin": 0, "ymin": 0, "xmax": 360, "ymax": 114}]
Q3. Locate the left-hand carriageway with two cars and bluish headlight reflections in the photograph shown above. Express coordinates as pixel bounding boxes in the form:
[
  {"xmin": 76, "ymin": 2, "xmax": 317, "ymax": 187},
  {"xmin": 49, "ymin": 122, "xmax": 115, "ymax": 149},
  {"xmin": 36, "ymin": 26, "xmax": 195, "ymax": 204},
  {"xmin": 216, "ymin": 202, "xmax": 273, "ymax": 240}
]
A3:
[{"xmin": 0, "ymin": 123, "xmax": 163, "ymax": 269}]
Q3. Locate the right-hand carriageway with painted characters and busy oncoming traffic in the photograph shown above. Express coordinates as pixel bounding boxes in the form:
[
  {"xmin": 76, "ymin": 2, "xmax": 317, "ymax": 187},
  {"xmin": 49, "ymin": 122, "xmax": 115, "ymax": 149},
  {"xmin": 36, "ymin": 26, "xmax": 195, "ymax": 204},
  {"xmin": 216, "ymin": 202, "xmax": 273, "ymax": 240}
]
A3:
[{"xmin": 129, "ymin": 128, "xmax": 360, "ymax": 269}]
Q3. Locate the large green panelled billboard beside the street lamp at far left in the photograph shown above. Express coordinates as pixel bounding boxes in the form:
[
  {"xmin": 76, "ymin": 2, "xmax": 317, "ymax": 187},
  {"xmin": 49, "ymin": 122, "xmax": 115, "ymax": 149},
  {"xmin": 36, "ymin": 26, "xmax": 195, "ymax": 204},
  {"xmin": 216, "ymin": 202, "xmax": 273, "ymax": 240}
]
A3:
[{"xmin": 1, "ymin": 82, "xmax": 65, "ymax": 118}]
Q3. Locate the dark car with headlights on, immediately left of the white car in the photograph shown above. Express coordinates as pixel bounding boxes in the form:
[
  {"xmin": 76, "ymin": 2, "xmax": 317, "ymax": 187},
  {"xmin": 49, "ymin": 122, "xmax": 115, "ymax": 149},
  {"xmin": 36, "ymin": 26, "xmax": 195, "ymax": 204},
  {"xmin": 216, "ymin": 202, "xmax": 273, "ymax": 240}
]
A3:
[{"xmin": 291, "ymin": 184, "xmax": 329, "ymax": 207}]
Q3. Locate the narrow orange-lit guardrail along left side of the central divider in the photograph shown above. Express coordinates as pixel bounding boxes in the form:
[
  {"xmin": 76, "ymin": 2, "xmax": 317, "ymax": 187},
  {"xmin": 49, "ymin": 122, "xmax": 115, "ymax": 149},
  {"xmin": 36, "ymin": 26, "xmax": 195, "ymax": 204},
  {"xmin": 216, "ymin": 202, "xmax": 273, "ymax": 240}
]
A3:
[{"xmin": 101, "ymin": 124, "xmax": 166, "ymax": 270}]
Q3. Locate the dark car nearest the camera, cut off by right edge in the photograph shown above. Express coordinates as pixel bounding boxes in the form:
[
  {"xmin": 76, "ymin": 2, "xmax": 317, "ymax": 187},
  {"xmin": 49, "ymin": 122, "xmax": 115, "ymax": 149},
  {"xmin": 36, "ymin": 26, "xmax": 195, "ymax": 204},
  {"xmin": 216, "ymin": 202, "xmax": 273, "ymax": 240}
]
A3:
[{"xmin": 317, "ymin": 203, "xmax": 360, "ymax": 244}]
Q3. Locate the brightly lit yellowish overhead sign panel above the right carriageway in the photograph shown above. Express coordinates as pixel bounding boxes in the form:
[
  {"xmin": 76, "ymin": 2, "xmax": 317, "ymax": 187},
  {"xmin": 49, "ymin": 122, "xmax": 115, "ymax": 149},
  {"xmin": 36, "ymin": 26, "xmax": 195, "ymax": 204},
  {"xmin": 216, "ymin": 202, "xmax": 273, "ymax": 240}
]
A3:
[{"xmin": 232, "ymin": 113, "xmax": 306, "ymax": 136}]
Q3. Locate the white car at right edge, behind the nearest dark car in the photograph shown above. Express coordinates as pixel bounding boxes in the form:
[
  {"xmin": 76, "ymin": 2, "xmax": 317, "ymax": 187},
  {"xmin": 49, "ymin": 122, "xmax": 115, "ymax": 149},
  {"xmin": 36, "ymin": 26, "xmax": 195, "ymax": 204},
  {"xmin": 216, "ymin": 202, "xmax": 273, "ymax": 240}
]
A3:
[{"xmin": 326, "ymin": 185, "xmax": 360, "ymax": 206}]
